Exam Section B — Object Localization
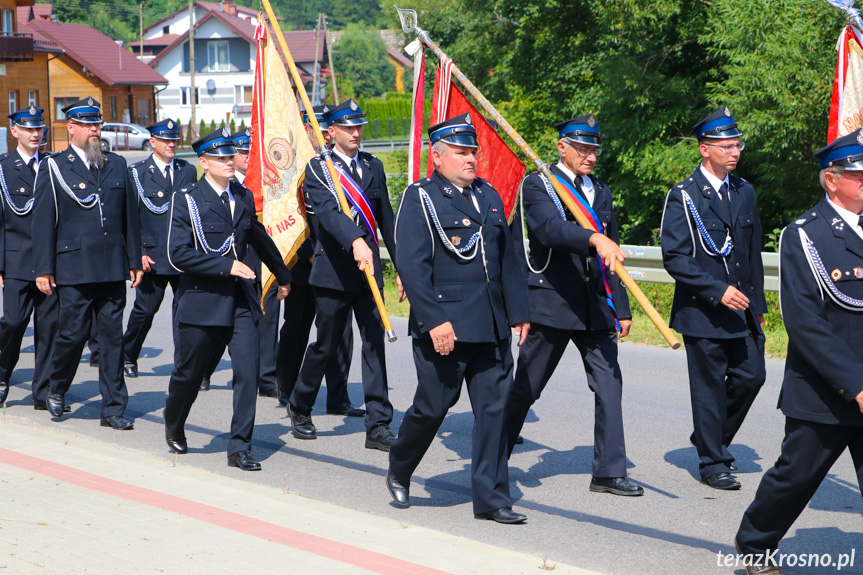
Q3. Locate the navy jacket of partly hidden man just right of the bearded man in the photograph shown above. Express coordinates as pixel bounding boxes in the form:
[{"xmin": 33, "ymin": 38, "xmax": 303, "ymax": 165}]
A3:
[{"xmin": 129, "ymin": 154, "xmax": 198, "ymax": 275}]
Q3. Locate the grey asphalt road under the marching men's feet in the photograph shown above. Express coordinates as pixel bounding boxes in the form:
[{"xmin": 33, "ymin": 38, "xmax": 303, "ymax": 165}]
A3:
[{"xmin": 0, "ymin": 291, "xmax": 863, "ymax": 575}]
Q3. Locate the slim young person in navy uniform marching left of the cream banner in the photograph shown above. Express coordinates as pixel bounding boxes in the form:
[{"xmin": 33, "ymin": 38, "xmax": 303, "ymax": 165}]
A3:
[{"xmin": 164, "ymin": 129, "xmax": 291, "ymax": 471}]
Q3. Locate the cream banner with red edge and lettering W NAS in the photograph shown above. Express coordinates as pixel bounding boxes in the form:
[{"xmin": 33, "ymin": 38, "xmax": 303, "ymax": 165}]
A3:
[{"xmin": 245, "ymin": 19, "xmax": 315, "ymax": 304}]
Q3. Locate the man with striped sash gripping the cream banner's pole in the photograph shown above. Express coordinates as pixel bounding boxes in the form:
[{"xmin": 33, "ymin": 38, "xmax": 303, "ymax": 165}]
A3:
[{"xmin": 288, "ymin": 100, "xmax": 395, "ymax": 451}]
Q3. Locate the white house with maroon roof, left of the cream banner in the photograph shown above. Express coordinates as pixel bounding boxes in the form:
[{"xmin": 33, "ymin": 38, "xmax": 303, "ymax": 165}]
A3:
[{"xmin": 145, "ymin": 0, "xmax": 327, "ymax": 126}]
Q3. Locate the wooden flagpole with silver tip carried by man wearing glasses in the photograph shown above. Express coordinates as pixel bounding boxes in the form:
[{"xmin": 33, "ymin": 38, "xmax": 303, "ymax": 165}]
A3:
[{"xmin": 398, "ymin": 7, "xmax": 680, "ymax": 349}]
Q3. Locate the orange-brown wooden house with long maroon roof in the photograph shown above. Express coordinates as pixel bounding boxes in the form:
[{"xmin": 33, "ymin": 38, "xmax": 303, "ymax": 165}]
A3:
[{"xmin": 19, "ymin": 4, "xmax": 168, "ymax": 150}]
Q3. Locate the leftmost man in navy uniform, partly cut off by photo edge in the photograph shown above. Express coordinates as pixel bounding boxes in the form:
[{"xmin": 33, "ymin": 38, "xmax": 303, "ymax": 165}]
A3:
[{"xmin": 0, "ymin": 106, "xmax": 58, "ymax": 409}]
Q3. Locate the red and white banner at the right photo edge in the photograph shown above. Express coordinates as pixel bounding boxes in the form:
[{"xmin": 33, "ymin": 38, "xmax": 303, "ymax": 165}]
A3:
[{"xmin": 827, "ymin": 26, "xmax": 863, "ymax": 144}]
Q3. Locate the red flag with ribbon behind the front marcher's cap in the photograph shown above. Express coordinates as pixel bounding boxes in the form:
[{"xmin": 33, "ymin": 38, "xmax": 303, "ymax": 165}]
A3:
[{"xmin": 427, "ymin": 67, "xmax": 526, "ymax": 220}]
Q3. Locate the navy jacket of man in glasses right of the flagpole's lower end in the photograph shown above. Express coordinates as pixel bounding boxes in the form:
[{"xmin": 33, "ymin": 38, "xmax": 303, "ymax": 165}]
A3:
[{"xmin": 661, "ymin": 168, "xmax": 767, "ymax": 339}]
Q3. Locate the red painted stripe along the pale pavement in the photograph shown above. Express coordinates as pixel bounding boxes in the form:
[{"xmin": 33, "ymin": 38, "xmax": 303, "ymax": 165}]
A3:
[{"xmin": 0, "ymin": 448, "xmax": 456, "ymax": 575}]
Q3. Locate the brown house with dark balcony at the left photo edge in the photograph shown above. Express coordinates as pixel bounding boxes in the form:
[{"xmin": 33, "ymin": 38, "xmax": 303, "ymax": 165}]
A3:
[{"xmin": 0, "ymin": 0, "xmax": 62, "ymax": 150}]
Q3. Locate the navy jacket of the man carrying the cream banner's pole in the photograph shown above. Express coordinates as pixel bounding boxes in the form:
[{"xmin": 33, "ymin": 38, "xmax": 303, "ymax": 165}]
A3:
[{"xmin": 303, "ymin": 152, "xmax": 395, "ymax": 292}]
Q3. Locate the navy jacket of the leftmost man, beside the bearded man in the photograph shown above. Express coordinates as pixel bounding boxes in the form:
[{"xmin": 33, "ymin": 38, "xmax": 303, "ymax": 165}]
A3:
[{"xmin": 0, "ymin": 148, "xmax": 45, "ymax": 281}]
